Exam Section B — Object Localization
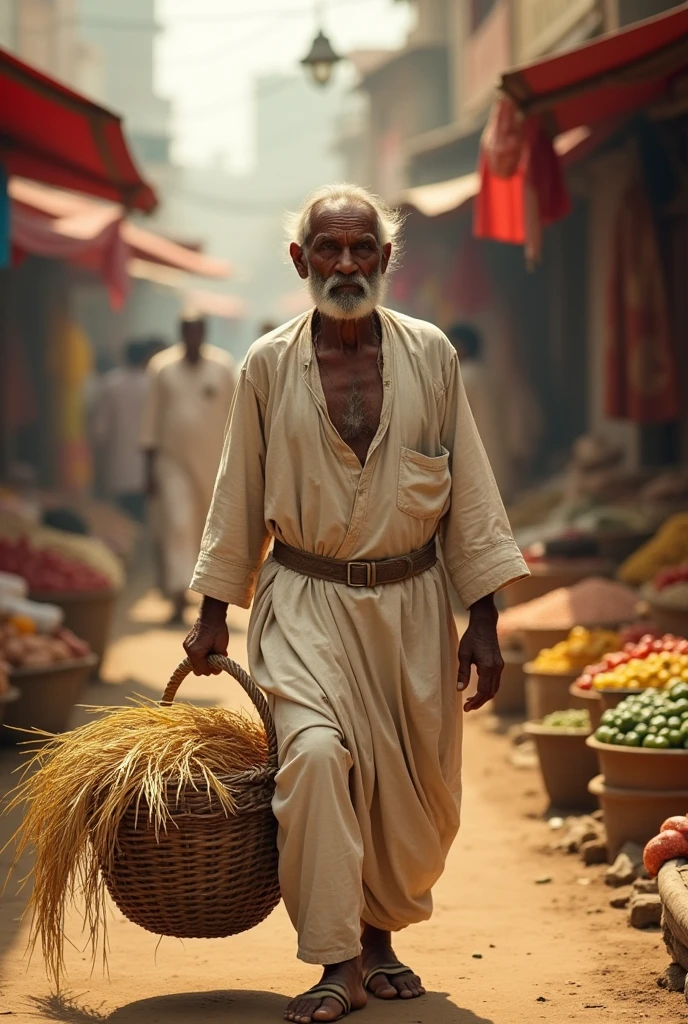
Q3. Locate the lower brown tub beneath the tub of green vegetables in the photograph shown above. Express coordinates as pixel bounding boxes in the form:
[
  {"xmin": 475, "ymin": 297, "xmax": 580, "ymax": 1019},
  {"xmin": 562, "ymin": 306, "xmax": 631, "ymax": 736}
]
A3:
[{"xmin": 589, "ymin": 774, "xmax": 688, "ymax": 863}]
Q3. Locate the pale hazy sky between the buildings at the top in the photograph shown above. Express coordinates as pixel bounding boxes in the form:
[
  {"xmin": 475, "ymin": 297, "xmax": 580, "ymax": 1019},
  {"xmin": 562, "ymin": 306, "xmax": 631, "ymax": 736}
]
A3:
[{"xmin": 157, "ymin": 0, "xmax": 413, "ymax": 170}]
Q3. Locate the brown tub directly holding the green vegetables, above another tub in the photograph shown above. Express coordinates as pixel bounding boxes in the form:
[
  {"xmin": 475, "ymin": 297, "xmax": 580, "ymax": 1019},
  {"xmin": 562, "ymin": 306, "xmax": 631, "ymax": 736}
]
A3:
[{"xmin": 588, "ymin": 736, "xmax": 688, "ymax": 790}]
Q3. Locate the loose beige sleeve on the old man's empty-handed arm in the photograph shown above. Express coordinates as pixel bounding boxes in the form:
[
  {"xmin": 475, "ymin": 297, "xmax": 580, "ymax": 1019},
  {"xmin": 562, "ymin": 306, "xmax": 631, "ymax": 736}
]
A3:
[{"xmin": 440, "ymin": 346, "xmax": 529, "ymax": 608}]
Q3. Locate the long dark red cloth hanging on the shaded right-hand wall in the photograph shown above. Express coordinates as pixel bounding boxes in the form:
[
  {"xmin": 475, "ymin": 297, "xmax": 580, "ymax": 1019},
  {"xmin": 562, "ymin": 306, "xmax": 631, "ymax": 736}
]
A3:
[{"xmin": 605, "ymin": 177, "xmax": 681, "ymax": 423}]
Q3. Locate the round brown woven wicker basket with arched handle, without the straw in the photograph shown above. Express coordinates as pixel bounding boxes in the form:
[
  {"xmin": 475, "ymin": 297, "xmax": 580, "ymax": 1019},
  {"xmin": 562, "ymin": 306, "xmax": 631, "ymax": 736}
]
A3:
[{"xmin": 102, "ymin": 655, "xmax": 280, "ymax": 939}]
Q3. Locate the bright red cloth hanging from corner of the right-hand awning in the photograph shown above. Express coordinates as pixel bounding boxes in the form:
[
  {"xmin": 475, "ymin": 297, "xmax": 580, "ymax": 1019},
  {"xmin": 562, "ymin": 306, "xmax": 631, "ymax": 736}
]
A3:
[{"xmin": 473, "ymin": 92, "xmax": 571, "ymax": 263}]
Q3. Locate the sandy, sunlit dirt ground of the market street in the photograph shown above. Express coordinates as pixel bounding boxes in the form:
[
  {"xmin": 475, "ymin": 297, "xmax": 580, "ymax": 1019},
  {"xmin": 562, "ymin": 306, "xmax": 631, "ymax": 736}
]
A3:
[{"xmin": 0, "ymin": 598, "xmax": 688, "ymax": 1024}]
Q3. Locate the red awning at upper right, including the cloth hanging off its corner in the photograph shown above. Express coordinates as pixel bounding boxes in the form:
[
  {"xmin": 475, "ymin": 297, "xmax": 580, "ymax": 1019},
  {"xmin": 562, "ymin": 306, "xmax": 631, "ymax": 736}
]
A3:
[{"xmin": 473, "ymin": 3, "xmax": 688, "ymax": 260}]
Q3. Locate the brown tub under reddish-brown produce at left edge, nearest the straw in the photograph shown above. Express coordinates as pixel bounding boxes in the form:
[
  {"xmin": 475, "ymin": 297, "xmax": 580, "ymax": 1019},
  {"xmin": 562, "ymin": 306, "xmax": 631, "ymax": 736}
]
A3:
[{"xmin": 2, "ymin": 654, "xmax": 97, "ymax": 743}]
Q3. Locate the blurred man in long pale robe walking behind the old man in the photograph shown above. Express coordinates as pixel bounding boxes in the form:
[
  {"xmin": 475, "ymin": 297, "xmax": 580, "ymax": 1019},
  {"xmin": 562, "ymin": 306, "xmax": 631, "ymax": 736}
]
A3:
[{"xmin": 139, "ymin": 314, "xmax": 237, "ymax": 625}]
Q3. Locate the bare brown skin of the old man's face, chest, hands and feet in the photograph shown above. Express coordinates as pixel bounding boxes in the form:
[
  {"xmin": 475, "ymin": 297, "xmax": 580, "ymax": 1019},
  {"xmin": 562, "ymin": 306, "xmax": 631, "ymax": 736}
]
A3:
[{"xmin": 184, "ymin": 205, "xmax": 504, "ymax": 1024}]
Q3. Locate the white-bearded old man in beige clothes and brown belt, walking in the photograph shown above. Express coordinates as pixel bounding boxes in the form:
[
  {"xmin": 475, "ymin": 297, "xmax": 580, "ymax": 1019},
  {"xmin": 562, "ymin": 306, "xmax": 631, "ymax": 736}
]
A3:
[{"xmin": 185, "ymin": 185, "xmax": 527, "ymax": 1024}]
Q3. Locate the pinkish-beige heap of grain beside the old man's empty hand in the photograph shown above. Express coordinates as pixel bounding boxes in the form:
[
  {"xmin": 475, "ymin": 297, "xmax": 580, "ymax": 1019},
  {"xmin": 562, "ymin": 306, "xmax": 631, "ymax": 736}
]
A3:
[{"xmin": 499, "ymin": 577, "xmax": 638, "ymax": 636}]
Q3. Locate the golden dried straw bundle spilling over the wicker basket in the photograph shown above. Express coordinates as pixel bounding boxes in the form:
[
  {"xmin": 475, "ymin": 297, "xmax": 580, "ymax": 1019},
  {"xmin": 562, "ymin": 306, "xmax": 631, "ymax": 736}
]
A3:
[{"xmin": 8, "ymin": 701, "xmax": 268, "ymax": 985}]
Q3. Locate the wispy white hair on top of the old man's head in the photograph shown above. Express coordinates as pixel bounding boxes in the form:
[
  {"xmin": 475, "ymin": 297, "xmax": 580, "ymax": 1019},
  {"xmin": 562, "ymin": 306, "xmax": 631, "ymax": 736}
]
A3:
[{"xmin": 285, "ymin": 181, "xmax": 403, "ymax": 271}]
